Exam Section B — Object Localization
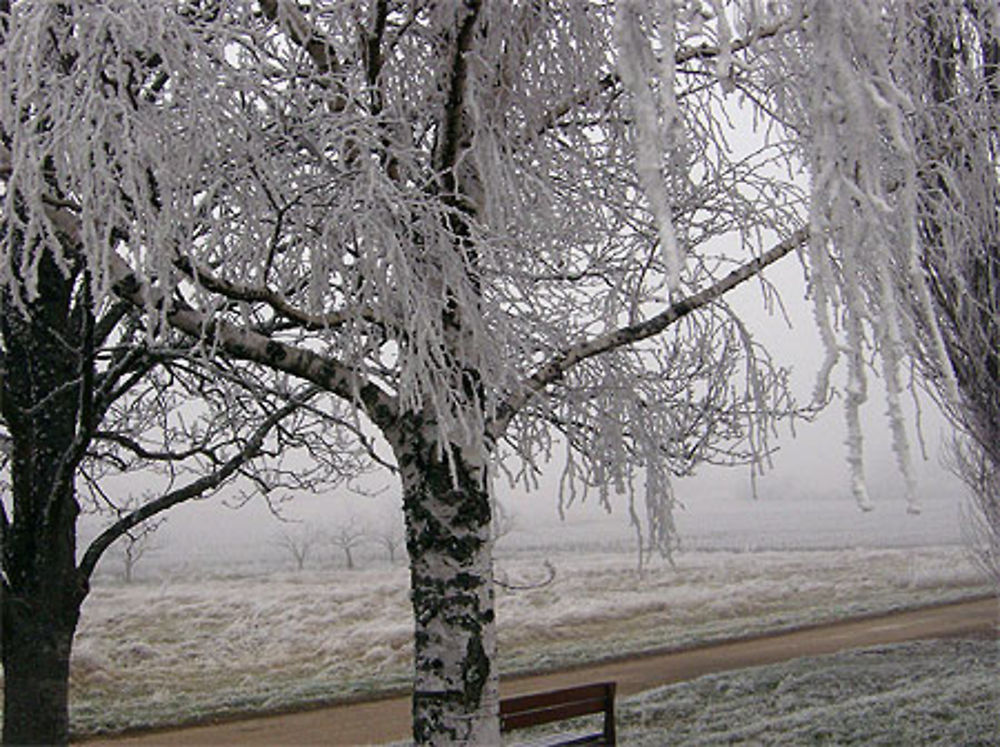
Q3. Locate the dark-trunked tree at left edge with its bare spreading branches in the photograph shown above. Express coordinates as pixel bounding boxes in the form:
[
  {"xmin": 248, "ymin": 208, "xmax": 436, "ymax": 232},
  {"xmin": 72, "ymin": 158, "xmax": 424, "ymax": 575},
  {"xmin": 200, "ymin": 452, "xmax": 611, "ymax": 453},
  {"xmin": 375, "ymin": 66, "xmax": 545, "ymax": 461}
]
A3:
[{"xmin": 0, "ymin": 312, "xmax": 359, "ymax": 744}]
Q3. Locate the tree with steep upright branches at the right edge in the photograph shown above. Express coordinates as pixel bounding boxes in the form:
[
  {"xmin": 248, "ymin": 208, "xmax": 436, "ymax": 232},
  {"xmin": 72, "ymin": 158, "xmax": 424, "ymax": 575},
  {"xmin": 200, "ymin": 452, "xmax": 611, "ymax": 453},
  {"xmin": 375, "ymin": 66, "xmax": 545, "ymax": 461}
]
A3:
[{"xmin": 900, "ymin": 0, "xmax": 1000, "ymax": 585}]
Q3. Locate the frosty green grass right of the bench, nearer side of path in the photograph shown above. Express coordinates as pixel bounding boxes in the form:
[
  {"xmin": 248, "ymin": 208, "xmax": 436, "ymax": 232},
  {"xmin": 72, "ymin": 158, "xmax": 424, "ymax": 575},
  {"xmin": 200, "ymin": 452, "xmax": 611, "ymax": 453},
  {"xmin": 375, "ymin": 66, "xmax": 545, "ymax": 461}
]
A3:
[{"xmin": 514, "ymin": 639, "xmax": 1000, "ymax": 747}]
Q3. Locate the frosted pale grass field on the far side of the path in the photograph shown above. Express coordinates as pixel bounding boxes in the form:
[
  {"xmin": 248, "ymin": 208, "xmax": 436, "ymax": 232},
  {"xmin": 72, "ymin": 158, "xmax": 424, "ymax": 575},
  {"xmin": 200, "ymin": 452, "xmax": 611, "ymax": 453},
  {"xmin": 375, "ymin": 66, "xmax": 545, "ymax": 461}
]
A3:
[{"xmin": 64, "ymin": 546, "xmax": 986, "ymax": 734}]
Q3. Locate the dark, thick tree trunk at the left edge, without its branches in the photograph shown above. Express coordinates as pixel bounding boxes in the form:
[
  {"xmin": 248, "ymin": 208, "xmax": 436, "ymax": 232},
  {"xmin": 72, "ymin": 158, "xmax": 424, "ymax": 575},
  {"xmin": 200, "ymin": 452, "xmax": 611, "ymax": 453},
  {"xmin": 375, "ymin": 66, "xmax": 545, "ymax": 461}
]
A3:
[{"xmin": 0, "ymin": 250, "xmax": 90, "ymax": 744}]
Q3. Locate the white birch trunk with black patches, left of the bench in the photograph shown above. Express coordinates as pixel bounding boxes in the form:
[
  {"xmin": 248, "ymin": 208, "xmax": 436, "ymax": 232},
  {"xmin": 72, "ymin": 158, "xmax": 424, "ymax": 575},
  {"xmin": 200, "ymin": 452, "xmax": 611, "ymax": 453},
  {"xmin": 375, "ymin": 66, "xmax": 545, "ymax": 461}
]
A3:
[{"xmin": 393, "ymin": 418, "xmax": 500, "ymax": 744}]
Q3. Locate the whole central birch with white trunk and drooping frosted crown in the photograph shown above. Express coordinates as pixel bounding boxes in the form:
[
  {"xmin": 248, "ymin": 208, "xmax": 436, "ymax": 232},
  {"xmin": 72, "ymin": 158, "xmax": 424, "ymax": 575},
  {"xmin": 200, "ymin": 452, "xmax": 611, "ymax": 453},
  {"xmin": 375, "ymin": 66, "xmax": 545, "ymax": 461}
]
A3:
[{"xmin": 0, "ymin": 0, "xmax": 976, "ymax": 743}]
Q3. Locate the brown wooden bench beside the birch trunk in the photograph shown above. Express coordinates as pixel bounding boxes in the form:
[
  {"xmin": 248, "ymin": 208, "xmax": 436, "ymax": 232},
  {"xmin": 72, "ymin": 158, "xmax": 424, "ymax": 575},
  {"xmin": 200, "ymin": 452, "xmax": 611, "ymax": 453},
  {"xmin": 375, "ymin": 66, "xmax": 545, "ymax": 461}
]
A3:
[{"xmin": 500, "ymin": 682, "xmax": 615, "ymax": 745}]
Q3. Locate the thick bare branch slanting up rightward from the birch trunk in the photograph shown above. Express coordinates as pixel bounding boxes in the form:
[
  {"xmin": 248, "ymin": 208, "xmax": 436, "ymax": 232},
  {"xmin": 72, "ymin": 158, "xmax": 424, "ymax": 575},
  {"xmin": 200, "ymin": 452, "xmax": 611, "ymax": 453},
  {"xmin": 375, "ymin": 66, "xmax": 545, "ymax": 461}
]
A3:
[{"xmin": 489, "ymin": 228, "xmax": 808, "ymax": 440}]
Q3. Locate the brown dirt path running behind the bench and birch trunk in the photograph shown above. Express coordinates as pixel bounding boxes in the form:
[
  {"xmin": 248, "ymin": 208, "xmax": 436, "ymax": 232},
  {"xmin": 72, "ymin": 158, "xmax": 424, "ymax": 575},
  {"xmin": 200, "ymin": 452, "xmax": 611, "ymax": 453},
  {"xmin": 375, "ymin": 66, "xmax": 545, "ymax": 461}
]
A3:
[{"xmin": 85, "ymin": 598, "xmax": 1000, "ymax": 747}]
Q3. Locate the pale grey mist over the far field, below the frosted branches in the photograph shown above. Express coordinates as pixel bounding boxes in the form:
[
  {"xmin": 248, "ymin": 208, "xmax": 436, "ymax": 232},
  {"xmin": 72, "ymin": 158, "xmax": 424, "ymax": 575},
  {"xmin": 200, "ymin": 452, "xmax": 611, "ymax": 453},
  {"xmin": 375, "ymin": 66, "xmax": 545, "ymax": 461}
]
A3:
[{"xmin": 88, "ymin": 406, "xmax": 967, "ymax": 578}]
